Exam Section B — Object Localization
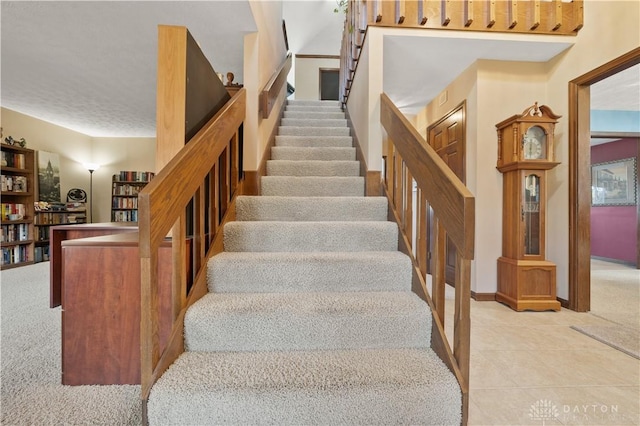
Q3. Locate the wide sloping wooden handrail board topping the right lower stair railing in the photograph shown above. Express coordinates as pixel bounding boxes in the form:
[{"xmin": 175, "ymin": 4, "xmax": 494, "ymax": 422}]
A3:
[{"xmin": 380, "ymin": 93, "xmax": 475, "ymax": 259}]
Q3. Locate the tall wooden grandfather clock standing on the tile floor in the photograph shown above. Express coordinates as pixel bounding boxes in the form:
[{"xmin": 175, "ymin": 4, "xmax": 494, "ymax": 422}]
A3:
[{"xmin": 496, "ymin": 102, "xmax": 560, "ymax": 311}]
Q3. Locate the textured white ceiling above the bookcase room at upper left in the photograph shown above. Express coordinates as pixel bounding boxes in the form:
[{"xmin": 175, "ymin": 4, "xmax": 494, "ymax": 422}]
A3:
[{"xmin": 1, "ymin": 1, "xmax": 256, "ymax": 137}]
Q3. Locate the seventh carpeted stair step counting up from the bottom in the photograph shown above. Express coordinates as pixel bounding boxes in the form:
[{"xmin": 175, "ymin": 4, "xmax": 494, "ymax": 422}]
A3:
[{"xmin": 267, "ymin": 160, "xmax": 360, "ymax": 176}]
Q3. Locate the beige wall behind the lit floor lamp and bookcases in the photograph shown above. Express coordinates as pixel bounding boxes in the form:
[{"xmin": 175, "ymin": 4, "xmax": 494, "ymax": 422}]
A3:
[{"xmin": 1, "ymin": 108, "xmax": 155, "ymax": 222}]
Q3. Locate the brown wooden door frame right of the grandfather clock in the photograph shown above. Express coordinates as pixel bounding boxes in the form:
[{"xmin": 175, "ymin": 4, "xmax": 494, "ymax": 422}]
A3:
[{"xmin": 563, "ymin": 47, "xmax": 640, "ymax": 312}]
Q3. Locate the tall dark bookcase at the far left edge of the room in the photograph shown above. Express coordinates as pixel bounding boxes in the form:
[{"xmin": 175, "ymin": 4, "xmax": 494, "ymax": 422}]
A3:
[{"xmin": 0, "ymin": 143, "xmax": 35, "ymax": 269}]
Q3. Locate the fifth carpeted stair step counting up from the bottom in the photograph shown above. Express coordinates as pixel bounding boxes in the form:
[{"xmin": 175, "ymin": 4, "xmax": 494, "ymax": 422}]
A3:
[{"xmin": 236, "ymin": 195, "xmax": 388, "ymax": 221}]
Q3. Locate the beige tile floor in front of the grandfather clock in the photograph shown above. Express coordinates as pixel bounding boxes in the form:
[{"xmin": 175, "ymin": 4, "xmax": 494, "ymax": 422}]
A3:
[{"xmin": 460, "ymin": 262, "xmax": 640, "ymax": 425}]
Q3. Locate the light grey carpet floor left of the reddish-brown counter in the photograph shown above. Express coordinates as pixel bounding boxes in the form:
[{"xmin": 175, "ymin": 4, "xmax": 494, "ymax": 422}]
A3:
[{"xmin": 0, "ymin": 262, "xmax": 142, "ymax": 425}]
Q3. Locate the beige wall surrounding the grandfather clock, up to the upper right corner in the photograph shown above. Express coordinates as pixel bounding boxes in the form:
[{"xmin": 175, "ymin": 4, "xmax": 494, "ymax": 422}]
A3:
[{"xmin": 415, "ymin": 1, "xmax": 640, "ymax": 299}]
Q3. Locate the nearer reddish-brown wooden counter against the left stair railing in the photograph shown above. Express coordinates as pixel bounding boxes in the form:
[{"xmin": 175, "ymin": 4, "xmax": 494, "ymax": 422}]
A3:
[{"xmin": 56, "ymin": 233, "xmax": 173, "ymax": 385}]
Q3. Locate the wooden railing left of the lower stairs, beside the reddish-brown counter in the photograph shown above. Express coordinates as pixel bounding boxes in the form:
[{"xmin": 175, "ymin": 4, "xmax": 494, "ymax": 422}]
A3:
[{"xmin": 138, "ymin": 89, "xmax": 246, "ymax": 399}]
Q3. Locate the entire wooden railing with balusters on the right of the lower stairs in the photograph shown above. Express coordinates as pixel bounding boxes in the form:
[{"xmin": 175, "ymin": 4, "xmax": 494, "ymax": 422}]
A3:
[{"xmin": 380, "ymin": 93, "xmax": 475, "ymax": 424}]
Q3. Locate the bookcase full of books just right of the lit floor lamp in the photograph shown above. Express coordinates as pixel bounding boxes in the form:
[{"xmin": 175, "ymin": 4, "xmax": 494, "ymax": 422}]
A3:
[{"xmin": 111, "ymin": 171, "xmax": 154, "ymax": 222}]
